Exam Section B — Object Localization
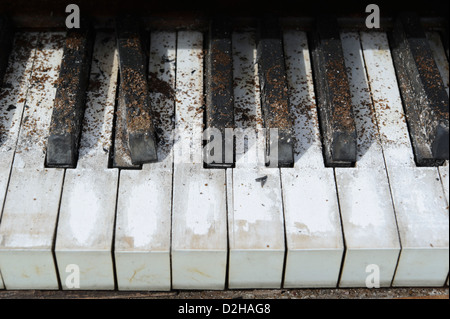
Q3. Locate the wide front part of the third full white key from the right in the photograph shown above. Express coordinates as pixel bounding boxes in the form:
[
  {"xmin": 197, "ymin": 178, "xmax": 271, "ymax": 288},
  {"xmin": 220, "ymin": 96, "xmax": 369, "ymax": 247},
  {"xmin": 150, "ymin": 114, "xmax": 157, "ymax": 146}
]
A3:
[{"xmin": 282, "ymin": 168, "xmax": 344, "ymax": 288}]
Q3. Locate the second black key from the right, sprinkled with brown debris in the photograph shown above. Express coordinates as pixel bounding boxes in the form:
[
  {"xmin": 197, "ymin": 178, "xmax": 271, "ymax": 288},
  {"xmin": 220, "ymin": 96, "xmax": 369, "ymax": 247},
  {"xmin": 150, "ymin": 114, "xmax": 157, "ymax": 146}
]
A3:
[{"xmin": 311, "ymin": 16, "xmax": 356, "ymax": 167}]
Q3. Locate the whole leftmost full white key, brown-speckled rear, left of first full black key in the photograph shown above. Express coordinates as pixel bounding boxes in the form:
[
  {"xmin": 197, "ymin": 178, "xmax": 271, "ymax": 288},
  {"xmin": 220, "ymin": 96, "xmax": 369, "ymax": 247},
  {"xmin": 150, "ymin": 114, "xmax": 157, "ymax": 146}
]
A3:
[{"xmin": 0, "ymin": 32, "xmax": 65, "ymax": 289}]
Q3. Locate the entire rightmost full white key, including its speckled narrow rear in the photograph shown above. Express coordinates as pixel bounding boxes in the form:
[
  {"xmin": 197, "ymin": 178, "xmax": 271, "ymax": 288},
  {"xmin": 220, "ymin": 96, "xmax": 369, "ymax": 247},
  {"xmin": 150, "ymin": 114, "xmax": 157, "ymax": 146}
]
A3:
[{"xmin": 361, "ymin": 32, "xmax": 449, "ymax": 286}]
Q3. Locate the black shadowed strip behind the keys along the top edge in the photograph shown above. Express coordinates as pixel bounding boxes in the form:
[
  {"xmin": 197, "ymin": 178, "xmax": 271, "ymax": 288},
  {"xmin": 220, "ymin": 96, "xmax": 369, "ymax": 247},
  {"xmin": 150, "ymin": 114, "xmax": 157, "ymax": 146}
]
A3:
[{"xmin": 0, "ymin": 0, "xmax": 449, "ymax": 28}]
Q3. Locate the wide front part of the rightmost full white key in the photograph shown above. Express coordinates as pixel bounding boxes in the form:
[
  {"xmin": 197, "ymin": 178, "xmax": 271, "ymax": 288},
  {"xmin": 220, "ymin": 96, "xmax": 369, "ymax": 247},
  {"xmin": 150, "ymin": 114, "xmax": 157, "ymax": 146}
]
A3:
[{"xmin": 389, "ymin": 167, "xmax": 449, "ymax": 286}]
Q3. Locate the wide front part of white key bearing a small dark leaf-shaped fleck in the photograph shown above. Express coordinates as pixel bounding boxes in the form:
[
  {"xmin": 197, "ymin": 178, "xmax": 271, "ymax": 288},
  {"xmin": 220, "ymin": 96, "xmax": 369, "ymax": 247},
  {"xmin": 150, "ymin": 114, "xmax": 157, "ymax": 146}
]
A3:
[{"xmin": 227, "ymin": 166, "xmax": 285, "ymax": 289}]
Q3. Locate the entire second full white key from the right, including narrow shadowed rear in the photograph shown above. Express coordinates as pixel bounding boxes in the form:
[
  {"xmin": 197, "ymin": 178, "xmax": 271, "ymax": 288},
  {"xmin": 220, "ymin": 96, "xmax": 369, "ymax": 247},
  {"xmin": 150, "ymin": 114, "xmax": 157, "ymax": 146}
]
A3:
[{"xmin": 336, "ymin": 33, "xmax": 400, "ymax": 287}]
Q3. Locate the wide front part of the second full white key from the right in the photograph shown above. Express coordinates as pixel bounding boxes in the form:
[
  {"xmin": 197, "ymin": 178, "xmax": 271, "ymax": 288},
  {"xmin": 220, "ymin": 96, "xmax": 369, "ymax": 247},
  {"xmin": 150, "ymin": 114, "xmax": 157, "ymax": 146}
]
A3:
[{"xmin": 336, "ymin": 168, "xmax": 400, "ymax": 287}]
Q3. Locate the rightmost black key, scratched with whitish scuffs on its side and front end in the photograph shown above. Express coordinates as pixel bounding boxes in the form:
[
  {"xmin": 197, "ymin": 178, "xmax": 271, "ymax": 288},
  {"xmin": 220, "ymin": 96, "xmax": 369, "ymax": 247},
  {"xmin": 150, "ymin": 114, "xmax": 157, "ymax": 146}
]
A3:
[{"xmin": 391, "ymin": 14, "xmax": 449, "ymax": 166}]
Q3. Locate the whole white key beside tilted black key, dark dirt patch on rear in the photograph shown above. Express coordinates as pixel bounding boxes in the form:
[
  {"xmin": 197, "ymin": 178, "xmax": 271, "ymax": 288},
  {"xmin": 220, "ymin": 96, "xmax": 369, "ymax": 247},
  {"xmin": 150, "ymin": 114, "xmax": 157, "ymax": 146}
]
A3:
[{"xmin": 114, "ymin": 32, "xmax": 176, "ymax": 290}]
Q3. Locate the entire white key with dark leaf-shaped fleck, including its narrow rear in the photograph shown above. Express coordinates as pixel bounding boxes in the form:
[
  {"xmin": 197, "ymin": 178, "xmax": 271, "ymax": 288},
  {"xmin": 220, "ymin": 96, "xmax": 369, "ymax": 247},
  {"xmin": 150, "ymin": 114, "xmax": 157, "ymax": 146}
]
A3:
[{"xmin": 227, "ymin": 32, "xmax": 285, "ymax": 289}]
